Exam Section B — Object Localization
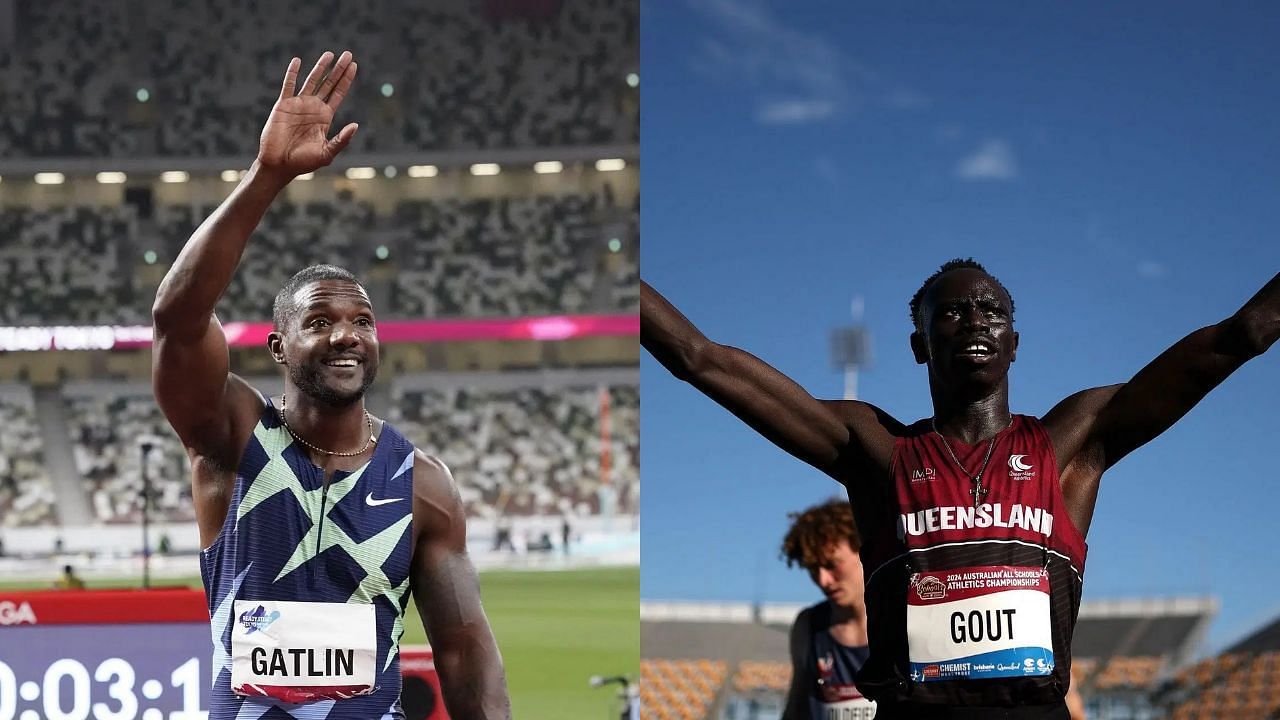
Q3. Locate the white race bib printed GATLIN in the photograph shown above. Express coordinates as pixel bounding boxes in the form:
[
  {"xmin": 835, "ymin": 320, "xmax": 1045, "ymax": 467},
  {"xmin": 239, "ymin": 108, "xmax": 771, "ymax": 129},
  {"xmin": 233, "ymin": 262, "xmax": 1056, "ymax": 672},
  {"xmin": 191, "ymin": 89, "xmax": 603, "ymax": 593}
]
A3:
[{"xmin": 232, "ymin": 600, "xmax": 378, "ymax": 702}]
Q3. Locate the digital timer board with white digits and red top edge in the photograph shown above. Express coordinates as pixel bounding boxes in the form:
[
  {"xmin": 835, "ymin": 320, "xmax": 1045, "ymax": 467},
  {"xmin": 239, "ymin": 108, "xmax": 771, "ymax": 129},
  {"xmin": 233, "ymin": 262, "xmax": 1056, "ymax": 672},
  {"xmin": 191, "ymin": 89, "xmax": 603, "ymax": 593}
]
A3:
[{"xmin": 0, "ymin": 589, "xmax": 212, "ymax": 720}]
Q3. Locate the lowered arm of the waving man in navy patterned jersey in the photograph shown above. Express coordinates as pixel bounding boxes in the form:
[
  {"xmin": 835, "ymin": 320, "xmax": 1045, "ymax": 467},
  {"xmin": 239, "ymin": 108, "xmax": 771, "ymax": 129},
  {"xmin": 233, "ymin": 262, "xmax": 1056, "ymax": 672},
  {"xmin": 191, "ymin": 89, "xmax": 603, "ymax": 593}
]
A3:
[{"xmin": 410, "ymin": 451, "xmax": 511, "ymax": 720}]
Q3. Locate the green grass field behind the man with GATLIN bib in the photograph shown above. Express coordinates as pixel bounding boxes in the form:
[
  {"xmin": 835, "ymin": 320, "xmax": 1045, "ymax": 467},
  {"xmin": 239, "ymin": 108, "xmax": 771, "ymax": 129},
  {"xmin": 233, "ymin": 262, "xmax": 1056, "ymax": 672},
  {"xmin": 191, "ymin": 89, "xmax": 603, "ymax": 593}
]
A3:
[{"xmin": 0, "ymin": 568, "xmax": 640, "ymax": 720}]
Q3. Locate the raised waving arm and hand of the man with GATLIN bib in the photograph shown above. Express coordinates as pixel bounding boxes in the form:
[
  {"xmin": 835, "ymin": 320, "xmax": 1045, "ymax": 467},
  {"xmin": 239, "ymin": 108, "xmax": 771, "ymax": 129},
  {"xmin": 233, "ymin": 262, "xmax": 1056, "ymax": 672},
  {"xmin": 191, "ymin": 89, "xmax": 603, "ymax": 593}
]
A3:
[{"xmin": 151, "ymin": 53, "xmax": 356, "ymax": 547}]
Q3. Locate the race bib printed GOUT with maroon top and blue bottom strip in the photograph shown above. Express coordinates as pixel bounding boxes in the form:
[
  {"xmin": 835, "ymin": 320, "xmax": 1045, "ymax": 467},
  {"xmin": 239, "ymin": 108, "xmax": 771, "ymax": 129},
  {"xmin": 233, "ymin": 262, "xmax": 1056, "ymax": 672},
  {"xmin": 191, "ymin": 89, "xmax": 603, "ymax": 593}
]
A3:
[{"xmin": 906, "ymin": 565, "xmax": 1053, "ymax": 683}]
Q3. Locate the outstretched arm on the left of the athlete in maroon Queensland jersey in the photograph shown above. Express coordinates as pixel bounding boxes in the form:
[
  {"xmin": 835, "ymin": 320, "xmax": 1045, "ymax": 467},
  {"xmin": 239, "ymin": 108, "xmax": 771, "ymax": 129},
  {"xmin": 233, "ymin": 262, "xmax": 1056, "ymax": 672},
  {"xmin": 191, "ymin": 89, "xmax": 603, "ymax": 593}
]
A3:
[{"xmin": 640, "ymin": 281, "xmax": 900, "ymax": 482}]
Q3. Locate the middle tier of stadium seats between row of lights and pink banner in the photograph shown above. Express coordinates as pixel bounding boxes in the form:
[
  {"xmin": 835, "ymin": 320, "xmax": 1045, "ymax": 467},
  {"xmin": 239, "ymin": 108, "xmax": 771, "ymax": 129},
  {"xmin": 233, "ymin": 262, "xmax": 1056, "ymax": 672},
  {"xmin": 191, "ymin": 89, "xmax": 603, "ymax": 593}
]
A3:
[{"xmin": 0, "ymin": 192, "xmax": 640, "ymax": 325}]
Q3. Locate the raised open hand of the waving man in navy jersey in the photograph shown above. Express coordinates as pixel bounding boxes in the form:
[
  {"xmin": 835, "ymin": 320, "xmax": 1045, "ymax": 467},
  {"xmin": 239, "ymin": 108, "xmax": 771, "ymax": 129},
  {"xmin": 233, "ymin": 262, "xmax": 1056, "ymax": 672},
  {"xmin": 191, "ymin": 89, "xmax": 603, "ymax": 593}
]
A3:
[{"xmin": 257, "ymin": 51, "xmax": 357, "ymax": 177}]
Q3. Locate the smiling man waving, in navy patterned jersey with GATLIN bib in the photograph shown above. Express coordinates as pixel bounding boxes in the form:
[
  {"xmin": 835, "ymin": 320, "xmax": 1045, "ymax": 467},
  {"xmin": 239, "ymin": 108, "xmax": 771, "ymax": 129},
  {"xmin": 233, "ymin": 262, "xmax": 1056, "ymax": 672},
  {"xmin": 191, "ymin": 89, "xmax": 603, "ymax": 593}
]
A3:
[{"xmin": 152, "ymin": 53, "xmax": 511, "ymax": 720}]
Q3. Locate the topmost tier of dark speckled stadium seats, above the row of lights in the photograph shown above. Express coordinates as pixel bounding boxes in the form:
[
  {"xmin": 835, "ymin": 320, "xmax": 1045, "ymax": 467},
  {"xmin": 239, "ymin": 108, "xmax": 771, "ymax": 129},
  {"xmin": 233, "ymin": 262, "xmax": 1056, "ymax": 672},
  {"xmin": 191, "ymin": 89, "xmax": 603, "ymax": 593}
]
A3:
[{"xmin": 0, "ymin": 0, "xmax": 639, "ymax": 158}]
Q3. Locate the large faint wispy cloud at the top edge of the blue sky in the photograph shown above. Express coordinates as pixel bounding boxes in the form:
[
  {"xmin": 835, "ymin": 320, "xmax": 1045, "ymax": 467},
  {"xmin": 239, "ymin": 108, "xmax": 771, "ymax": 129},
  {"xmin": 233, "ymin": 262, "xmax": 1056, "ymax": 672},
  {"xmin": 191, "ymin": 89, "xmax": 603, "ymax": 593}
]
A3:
[{"xmin": 686, "ymin": 0, "xmax": 927, "ymax": 124}]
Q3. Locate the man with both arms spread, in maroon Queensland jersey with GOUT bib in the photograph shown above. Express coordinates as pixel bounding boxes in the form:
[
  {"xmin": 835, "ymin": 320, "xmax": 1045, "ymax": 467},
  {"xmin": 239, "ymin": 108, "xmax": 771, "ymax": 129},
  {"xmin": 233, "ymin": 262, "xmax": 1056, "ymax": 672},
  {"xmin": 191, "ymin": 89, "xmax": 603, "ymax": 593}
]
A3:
[{"xmin": 650, "ymin": 260, "xmax": 1280, "ymax": 720}]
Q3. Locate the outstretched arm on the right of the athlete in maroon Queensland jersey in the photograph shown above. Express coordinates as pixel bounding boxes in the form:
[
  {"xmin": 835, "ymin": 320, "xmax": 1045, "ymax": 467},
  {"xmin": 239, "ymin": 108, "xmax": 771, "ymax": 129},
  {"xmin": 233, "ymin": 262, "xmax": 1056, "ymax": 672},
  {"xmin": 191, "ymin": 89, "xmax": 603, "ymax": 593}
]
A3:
[{"xmin": 1044, "ymin": 274, "xmax": 1280, "ymax": 532}]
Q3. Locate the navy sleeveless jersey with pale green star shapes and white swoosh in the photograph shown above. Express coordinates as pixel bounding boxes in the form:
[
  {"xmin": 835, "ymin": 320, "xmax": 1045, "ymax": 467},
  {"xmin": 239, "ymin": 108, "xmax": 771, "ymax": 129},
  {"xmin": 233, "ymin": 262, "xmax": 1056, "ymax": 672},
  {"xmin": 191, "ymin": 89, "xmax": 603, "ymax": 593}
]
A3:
[{"xmin": 201, "ymin": 400, "xmax": 413, "ymax": 720}]
